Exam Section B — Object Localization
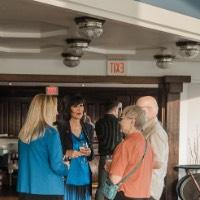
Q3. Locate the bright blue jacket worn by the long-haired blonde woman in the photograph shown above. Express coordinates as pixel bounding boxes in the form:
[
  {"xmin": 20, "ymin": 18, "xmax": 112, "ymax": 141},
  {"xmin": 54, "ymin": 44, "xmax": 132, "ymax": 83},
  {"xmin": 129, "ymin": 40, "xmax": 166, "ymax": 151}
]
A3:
[{"xmin": 17, "ymin": 127, "xmax": 68, "ymax": 195}]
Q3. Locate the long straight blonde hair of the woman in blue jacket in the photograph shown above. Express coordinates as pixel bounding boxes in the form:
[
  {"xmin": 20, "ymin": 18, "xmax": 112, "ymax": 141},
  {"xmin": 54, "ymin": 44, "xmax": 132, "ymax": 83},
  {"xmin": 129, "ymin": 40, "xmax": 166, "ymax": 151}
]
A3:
[{"xmin": 19, "ymin": 94, "xmax": 57, "ymax": 143}]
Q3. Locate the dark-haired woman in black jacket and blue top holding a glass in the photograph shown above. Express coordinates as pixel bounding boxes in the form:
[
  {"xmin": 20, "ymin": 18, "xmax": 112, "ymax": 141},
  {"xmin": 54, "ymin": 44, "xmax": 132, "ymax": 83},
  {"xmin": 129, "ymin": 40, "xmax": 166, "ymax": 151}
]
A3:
[{"xmin": 57, "ymin": 95, "xmax": 94, "ymax": 200}]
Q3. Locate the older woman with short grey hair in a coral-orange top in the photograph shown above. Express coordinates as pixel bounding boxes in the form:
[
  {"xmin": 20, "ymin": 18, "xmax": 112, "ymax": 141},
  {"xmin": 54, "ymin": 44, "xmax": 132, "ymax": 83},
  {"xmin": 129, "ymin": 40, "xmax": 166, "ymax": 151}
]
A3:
[{"xmin": 109, "ymin": 105, "xmax": 153, "ymax": 200}]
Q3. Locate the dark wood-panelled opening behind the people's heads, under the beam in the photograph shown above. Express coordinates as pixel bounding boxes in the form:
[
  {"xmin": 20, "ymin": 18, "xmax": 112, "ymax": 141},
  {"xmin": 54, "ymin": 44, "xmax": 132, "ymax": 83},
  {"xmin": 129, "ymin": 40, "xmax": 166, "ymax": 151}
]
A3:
[{"xmin": 0, "ymin": 86, "xmax": 159, "ymax": 137}]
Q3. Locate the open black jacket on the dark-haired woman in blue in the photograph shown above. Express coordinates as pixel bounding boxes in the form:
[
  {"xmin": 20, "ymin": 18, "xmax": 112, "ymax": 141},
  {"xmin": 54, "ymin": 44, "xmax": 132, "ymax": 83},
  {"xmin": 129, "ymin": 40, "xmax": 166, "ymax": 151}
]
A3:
[{"xmin": 57, "ymin": 121, "xmax": 94, "ymax": 160}]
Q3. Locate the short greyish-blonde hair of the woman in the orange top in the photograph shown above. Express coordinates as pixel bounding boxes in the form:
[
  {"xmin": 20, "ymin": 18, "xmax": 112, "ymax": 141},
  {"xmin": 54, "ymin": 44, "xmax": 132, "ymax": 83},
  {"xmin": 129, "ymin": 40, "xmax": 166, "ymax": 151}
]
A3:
[{"xmin": 122, "ymin": 105, "xmax": 146, "ymax": 130}]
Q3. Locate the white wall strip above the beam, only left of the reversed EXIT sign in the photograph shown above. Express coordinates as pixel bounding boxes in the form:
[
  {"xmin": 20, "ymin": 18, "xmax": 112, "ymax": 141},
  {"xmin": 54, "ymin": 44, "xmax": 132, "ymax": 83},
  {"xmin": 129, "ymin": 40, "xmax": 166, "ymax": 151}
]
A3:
[{"xmin": 0, "ymin": 58, "xmax": 106, "ymax": 75}]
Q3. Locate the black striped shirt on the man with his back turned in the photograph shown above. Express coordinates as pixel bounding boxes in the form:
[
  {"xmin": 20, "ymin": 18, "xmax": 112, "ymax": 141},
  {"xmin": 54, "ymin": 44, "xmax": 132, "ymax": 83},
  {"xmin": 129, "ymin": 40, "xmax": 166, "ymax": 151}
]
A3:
[{"xmin": 95, "ymin": 114, "xmax": 123, "ymax": 155}]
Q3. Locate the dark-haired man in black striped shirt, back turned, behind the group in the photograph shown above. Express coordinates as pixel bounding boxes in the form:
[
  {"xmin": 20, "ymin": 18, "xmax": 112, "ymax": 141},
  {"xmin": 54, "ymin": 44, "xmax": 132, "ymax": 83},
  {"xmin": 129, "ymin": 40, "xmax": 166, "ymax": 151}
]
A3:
[{"xmin": 95, "ymin": 99, "xmax": 123, "ymax": 200}]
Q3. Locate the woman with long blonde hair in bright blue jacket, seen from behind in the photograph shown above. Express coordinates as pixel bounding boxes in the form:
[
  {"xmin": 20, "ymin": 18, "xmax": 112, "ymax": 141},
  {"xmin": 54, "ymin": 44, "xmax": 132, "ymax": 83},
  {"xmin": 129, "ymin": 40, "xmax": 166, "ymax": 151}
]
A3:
[{"xmin": 17, "ymin": 94, "xmax": 68, "ymax": 200}]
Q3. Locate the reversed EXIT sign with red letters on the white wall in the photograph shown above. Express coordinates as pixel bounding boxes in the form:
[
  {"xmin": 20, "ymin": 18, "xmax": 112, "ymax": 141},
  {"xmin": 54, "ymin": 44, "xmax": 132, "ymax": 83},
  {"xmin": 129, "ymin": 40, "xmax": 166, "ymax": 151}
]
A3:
[{"xmin": 107, "ymin": 60, "xmax": 127, "ymax": 76}]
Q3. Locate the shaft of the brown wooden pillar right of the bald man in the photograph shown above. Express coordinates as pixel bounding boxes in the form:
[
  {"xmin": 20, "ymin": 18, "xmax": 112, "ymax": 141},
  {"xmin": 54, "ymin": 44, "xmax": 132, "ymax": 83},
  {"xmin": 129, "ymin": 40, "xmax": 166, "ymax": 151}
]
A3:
[{"xmin": 165, "ymin": 92, "xmax": 180, "ymax": 200}]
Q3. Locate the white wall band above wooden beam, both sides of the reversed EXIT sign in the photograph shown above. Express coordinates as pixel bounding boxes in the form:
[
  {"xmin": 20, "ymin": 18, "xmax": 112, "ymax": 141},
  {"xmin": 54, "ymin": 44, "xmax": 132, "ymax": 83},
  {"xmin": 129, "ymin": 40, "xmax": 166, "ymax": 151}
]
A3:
[{"xmin": 0, "ymin": 58, "xmax": 200, "ymax": 82}]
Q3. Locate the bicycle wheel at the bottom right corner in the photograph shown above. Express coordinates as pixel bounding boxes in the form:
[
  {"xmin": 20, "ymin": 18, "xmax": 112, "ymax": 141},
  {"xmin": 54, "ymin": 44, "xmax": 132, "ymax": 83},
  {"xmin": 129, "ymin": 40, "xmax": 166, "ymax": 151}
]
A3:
[{"xmin": 179, "ymin": 173, "xmax": 200, "ymax": 200}]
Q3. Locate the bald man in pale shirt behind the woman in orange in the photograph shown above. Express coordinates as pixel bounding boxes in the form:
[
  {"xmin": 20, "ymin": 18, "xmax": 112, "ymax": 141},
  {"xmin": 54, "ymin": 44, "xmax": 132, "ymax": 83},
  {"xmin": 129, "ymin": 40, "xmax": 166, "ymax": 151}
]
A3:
[{"xmin": 136, "ymin": 96, "xmax": 169, "ymax": 200}]
